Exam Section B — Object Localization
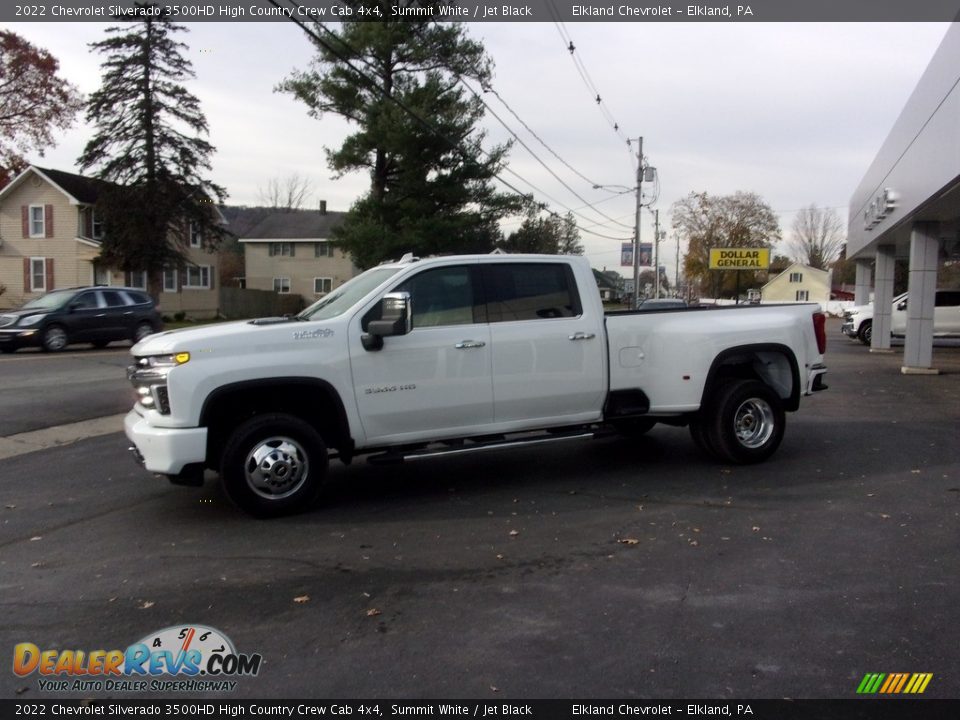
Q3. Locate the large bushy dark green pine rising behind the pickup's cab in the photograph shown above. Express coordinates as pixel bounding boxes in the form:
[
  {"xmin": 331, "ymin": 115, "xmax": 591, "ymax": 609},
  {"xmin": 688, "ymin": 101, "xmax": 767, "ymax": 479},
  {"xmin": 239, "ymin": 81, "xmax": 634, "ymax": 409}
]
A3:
[{"xmin": 278, "ymin": 10, "xmax": 520, "ymax": 267}]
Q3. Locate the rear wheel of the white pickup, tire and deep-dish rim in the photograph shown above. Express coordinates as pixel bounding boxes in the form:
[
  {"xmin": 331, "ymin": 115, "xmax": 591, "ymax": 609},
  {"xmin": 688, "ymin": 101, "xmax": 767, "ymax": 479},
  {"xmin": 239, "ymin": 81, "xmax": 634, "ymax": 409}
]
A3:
[{"xmin": 702, "ymin": 380, "xmax": 786, "ymax": 464}]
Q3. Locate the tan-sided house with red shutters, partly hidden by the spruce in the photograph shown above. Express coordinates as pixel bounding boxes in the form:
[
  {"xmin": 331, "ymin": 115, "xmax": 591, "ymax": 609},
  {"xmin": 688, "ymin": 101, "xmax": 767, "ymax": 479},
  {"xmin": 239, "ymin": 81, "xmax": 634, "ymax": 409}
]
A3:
[{"xmin": 0, "ymin": 166, "xmax": 219, "ymax": 317}]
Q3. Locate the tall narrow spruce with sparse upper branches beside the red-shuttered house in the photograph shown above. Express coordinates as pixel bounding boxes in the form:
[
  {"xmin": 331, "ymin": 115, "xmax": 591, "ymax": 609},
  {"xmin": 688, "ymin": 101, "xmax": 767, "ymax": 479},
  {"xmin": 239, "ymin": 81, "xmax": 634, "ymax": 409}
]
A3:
[{"xmin": 77, "ymin": 4, "xmax": 226, "ymax": 288}]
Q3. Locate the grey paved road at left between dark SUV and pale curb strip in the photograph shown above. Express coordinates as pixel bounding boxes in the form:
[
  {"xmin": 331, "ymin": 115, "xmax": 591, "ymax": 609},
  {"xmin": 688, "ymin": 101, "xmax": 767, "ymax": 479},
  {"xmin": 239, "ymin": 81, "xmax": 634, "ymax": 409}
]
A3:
[{"xmin": 0, "ymin": 344, "xmax": 133, "ymax": 437}]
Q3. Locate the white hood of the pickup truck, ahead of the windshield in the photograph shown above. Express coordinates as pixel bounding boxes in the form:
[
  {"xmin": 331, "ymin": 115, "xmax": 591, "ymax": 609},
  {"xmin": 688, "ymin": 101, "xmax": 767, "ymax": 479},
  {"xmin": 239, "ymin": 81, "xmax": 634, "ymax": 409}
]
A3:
[{"xmin": 130, "ymin": 318, "xmax": 340, "ymax": 356}]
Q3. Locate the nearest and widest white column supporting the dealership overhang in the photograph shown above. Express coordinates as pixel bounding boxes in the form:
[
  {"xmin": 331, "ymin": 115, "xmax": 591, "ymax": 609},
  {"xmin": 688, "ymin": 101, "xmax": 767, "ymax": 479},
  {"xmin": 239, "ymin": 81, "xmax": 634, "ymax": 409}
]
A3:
[{"xmin": 900, "ymin": 223, "xmax": 939, "ymax": 375}]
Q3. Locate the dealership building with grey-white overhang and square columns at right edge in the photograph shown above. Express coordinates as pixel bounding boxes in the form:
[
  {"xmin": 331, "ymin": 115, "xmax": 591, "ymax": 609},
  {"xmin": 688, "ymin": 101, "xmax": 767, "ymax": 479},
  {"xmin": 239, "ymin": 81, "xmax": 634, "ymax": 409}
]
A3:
[{"xmin": 847, "ymin": 22, "xmax": 960, "ymax": 374}]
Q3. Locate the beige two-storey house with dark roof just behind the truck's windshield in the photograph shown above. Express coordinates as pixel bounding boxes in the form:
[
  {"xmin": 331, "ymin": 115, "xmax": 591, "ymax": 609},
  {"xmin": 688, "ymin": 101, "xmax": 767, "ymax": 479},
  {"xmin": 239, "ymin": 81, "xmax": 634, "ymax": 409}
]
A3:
[{"xmin": 240, "ymin": 202, "xmax": 359, "ymax": 305}]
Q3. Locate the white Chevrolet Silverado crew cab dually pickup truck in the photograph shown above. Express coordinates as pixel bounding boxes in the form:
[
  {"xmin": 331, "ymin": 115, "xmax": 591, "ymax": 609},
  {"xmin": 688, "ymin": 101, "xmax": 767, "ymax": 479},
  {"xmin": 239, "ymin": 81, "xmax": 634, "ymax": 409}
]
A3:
[{"xmin": 124, "ymin": 255, "xmax": 826, "ymax": 516}]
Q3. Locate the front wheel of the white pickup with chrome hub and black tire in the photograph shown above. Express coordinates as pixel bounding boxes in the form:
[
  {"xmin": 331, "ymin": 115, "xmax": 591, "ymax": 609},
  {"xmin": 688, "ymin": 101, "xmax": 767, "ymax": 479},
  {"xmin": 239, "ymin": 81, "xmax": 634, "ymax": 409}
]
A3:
[{"xmin": 220, "ymin": 413, "xmax": 328, "ymax": 517}]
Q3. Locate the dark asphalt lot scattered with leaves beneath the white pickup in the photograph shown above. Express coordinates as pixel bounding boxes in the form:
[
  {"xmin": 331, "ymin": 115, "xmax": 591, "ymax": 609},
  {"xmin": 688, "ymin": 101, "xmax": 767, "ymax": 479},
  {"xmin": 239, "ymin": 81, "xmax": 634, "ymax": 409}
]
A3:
[{"xmin": 0, "ymin": 324, "xmax": 960, "ymax": 700}]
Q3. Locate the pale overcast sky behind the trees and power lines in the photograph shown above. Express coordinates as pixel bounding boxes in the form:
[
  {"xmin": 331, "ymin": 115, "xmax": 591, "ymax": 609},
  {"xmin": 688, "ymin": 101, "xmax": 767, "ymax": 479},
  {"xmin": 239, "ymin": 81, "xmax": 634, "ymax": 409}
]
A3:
[{"xmin": 9, "ymin": 22, "xmax": 947, "ymax": 280}]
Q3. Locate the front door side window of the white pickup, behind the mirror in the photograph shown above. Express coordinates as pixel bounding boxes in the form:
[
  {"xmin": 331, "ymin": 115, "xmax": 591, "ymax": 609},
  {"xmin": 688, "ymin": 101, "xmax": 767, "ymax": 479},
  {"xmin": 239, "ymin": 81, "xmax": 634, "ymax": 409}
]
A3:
[{"xmin": 395, "ymin": 265, "xmax": 484, "ymax": 330}]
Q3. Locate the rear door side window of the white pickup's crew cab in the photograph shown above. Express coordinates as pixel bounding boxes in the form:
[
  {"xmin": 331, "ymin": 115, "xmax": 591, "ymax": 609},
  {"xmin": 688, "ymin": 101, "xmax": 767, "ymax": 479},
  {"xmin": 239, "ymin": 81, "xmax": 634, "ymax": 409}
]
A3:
[{"xmin": 485, "ymin": 263, "xmax": 582, "ymax": 322}]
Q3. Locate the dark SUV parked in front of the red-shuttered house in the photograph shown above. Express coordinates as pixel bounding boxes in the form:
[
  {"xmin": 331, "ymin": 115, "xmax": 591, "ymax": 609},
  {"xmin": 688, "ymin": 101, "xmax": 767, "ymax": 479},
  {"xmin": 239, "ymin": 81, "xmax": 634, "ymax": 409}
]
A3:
[{"xmin": 0, "ymin": 287, "xmax": 163, "ymax": 352}]
